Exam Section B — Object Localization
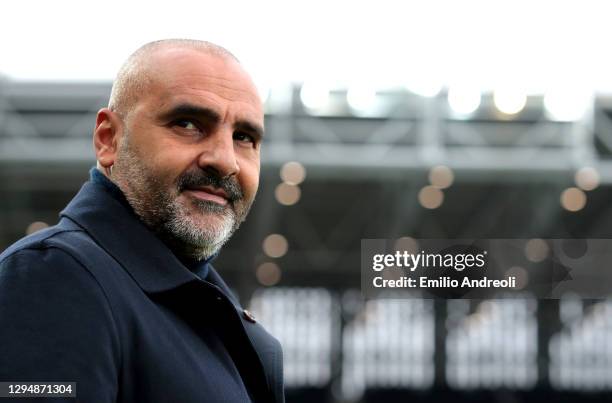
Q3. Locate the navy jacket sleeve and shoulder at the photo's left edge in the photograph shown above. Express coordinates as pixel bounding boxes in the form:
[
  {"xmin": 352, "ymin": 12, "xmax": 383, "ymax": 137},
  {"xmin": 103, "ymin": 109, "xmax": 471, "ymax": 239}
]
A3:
[{"xmin": 0, "ymin": 228, "xmax": 121, "ymax": 402}]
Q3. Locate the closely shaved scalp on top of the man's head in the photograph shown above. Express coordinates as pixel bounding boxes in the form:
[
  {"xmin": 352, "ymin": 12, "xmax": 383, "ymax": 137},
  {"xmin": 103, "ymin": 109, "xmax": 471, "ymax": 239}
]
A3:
[{"xmin": 108, "ymin": 39, "xmax": 238, "ymax": 117}]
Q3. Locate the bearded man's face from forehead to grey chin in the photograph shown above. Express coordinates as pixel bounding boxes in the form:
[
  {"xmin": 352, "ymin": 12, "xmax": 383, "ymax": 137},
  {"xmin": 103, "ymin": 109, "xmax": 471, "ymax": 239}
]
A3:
[{"xmin": 112, "ymin": 49, "xmax": 263, "ymax": 260}]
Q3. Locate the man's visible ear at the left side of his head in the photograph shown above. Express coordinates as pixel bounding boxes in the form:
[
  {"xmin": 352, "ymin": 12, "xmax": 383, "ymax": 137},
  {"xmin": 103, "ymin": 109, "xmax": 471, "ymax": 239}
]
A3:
[{"xmin": 94, "ymin": 108, "xmax": 123, "ymax": 170}]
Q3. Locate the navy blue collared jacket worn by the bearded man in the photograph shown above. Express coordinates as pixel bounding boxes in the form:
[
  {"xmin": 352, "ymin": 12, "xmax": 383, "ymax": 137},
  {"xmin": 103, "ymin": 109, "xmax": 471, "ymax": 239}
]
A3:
[{"xmin": 0, "ymin": 175, "xmax": 284, "ymax": 403}]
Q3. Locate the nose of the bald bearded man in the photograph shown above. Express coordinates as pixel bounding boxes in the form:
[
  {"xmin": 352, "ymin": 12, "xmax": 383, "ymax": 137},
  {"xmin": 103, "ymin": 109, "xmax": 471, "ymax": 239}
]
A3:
[{"xmin": 198, "ymin": 129, "xmax": 240, "ymax": 178}]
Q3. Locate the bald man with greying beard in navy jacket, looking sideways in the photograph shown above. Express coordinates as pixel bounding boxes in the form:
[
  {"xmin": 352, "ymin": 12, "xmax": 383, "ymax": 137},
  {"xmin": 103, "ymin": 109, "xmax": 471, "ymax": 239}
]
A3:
[{"xmin": 0, "ymin": 40, "xmax": 283, "ymax": 403}]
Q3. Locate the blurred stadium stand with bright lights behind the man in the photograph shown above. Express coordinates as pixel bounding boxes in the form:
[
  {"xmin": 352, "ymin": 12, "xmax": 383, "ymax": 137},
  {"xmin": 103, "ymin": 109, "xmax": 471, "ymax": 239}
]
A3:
[{"xmin": 0, "ymin": 2, "xmax": 612, "ymax": 403}]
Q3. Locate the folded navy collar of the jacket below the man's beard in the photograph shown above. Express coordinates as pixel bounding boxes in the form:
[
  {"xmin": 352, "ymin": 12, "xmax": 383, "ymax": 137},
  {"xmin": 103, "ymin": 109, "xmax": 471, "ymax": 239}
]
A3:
[{"xmin": 60, "ymin": 170, "xmax": 199, "ymax": 293}]
